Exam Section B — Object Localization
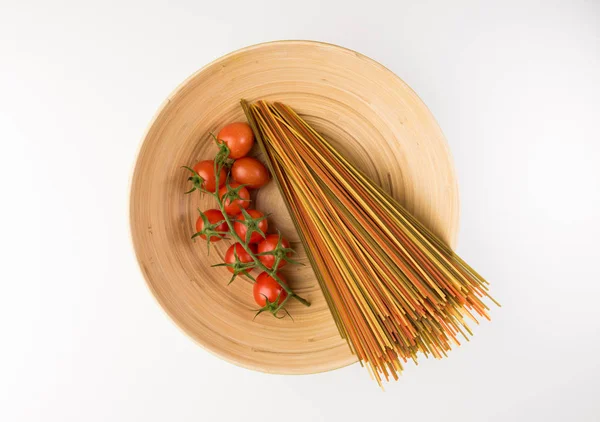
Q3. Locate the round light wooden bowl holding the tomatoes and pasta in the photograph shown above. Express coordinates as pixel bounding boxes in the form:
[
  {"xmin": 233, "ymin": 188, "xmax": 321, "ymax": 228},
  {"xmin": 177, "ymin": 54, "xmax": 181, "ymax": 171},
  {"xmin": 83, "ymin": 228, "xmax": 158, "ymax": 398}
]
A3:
[{"xmin": 130, "ymin": 41, "xmax": 458, "ymax": 374}]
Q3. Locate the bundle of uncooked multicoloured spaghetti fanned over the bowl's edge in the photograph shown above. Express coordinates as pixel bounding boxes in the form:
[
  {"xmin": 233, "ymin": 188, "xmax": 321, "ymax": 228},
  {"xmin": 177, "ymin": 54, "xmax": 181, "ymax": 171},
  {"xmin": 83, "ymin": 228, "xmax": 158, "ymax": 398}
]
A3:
[{"xmin": 242, "ymin": 100, "xmax": 493, "ymax": 385}]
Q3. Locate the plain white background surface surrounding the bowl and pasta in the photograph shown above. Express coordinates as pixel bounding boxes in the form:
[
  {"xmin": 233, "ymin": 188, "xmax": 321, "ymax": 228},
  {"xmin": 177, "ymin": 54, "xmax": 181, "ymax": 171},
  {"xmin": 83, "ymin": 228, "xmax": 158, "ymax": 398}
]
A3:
[{"xmin": 0, "ymin": 0, "xmax": 600, "ymax": 422}]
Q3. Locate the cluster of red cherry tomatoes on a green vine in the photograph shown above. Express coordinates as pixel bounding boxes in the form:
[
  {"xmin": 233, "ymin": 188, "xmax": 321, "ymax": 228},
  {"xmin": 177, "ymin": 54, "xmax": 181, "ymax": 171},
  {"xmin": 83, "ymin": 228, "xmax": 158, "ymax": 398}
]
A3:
[{"xmin": 186, "ymin": 122, "xmax": 298, "ymax": 316}]
